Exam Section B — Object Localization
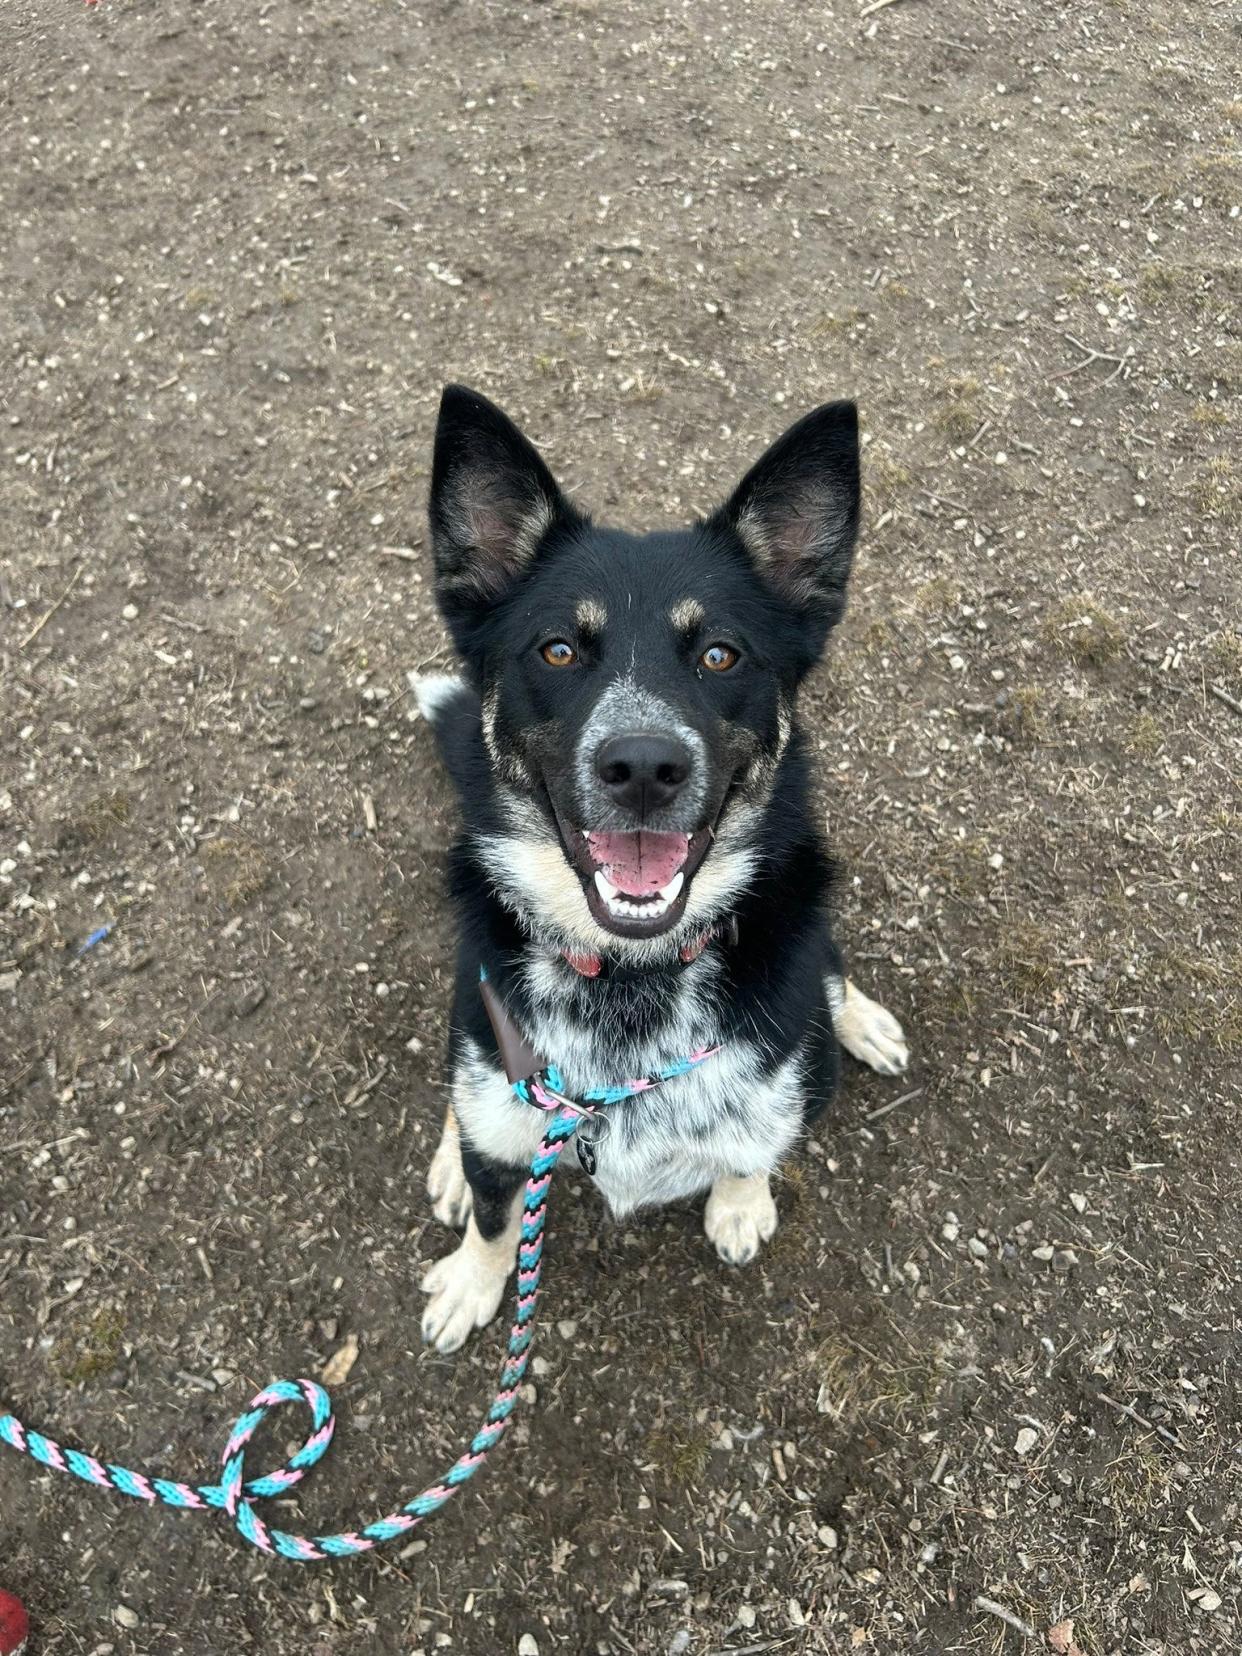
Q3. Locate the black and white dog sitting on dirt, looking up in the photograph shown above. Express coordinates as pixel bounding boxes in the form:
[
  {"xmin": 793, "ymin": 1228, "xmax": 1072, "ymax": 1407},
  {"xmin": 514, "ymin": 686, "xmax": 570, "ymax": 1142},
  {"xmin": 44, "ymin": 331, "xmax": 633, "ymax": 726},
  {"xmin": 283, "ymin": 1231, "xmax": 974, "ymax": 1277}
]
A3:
[{"xmin": 416, "ymin": 386, "xmax": 906, "ymax": 1351}]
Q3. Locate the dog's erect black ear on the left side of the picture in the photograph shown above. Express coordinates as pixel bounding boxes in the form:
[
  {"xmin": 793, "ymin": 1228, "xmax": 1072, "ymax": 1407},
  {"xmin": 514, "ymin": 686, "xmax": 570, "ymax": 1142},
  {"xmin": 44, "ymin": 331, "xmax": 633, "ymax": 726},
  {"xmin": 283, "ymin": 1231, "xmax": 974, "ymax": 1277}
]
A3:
[{"xmin": 431, "ymin": 386, "xmax": 578, "ymax": 604}]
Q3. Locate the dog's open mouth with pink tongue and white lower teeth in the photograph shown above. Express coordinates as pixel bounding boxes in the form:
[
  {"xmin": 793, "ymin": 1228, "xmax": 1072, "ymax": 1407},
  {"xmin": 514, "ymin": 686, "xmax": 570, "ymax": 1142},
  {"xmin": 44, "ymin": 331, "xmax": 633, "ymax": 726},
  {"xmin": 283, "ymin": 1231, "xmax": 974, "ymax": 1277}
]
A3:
[{"xmin": 556, "ymin": 815, "xmax": 712, "ymax": 937}]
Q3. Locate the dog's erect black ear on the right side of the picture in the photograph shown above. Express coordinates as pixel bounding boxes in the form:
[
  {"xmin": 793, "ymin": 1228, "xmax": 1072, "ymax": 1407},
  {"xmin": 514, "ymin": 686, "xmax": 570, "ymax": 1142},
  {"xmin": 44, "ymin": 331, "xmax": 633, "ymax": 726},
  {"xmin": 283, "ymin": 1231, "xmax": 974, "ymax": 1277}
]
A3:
[{"xmin": 717, "ymin": 402, "xmax": 861, "ymax": 626}]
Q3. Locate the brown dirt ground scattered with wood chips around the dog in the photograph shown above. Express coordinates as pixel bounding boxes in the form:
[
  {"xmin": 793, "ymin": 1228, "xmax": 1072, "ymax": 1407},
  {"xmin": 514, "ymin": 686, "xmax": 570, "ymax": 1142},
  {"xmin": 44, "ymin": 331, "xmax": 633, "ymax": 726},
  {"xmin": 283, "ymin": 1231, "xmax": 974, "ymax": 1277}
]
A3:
[{"xmin": 0, "ymin": 0, "xmax": 1242, "ymax": 1656}]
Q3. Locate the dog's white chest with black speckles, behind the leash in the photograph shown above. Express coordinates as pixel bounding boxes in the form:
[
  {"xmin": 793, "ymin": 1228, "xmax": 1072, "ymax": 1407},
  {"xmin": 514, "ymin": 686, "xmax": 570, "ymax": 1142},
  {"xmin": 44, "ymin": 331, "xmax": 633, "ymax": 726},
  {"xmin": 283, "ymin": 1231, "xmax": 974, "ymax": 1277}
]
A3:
[{"xmin": 455, "ymin": 969, "xmax": 805, "ymax": 1214}]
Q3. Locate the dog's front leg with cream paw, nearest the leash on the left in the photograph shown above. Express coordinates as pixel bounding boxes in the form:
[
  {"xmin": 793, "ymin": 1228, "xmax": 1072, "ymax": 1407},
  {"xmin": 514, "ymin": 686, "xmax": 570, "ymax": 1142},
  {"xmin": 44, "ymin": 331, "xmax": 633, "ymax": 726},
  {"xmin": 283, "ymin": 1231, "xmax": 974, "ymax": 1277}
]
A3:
[{"xmin": 422, "ymin": 1144, "xmax": 525, "ymax": 1351}]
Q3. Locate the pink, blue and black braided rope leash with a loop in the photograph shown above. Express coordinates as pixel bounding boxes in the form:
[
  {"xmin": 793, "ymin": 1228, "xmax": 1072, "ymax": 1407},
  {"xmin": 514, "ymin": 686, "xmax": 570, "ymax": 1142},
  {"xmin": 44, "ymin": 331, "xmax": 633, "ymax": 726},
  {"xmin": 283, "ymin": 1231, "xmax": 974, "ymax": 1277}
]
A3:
[{"xmin": 0, "ymin": 1048, "xmax": 715, "ymax": 1562}]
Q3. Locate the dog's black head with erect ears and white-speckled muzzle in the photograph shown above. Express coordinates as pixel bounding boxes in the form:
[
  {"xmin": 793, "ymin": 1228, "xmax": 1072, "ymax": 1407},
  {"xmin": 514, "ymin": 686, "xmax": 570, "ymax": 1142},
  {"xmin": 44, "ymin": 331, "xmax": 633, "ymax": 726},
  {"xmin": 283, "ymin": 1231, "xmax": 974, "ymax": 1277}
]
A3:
[{"xmin": 431, "ymin": 386, "xmax": 859, "ymax": 960}]
